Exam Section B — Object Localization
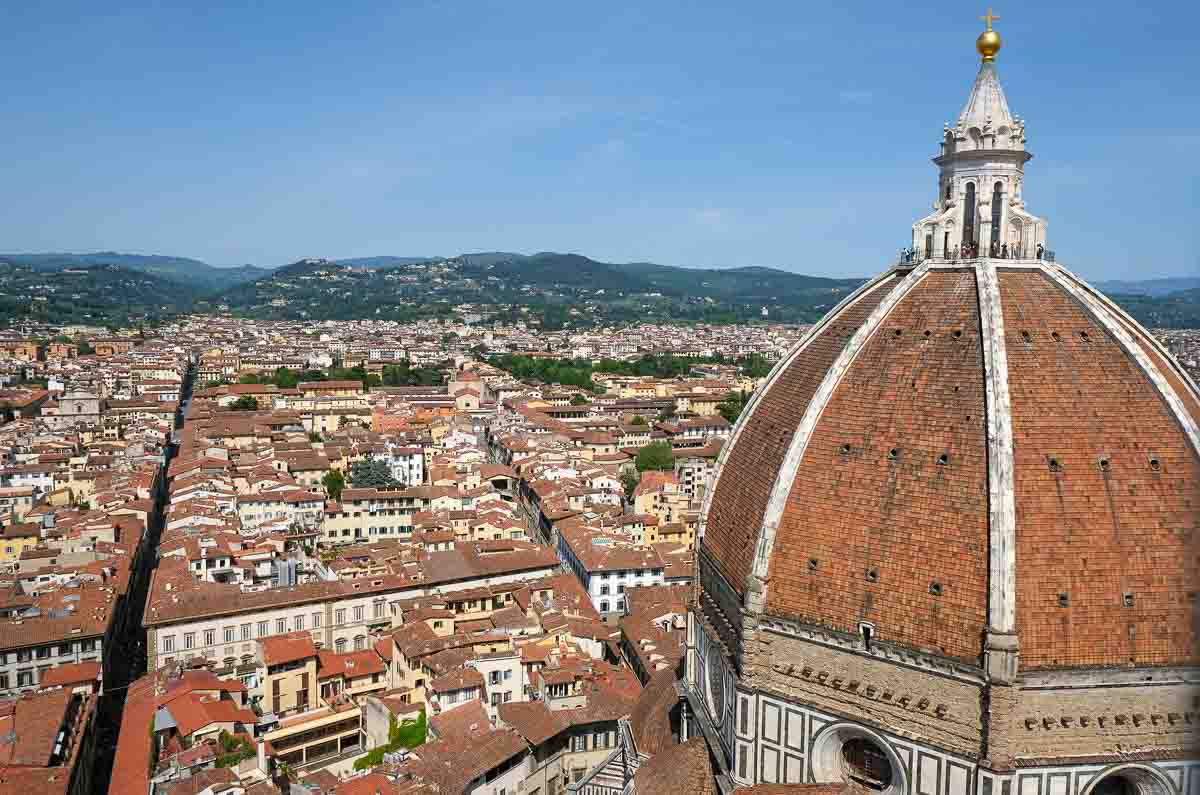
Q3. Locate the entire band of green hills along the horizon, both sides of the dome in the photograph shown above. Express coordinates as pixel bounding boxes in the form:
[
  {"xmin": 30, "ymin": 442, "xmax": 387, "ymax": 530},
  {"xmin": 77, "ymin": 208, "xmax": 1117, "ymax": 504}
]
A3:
[{"xmin": 0, "ymin": 251, "xmax": 1200, "ymax": 328}]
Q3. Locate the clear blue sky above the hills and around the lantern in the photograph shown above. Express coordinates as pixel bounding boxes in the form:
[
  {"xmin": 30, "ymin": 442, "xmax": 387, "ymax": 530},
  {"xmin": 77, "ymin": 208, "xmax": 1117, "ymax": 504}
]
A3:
[{"xmin": 0, "ymin": 0, "xmax": 1200, "ymax": 279}]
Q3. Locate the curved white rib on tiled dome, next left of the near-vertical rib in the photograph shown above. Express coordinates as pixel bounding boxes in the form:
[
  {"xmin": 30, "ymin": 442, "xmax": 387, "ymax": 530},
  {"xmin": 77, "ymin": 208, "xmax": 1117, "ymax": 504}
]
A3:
[{"xmin": 746, "ymin": 263, "xmax": 930, "ymax": 612}]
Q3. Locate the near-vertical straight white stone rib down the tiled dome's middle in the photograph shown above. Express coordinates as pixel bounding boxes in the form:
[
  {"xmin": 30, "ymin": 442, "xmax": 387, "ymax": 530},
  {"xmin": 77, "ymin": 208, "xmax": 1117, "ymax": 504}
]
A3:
[{"xmin": 974, "ymin": 259, "xmax": 1016, "ymax": 634}]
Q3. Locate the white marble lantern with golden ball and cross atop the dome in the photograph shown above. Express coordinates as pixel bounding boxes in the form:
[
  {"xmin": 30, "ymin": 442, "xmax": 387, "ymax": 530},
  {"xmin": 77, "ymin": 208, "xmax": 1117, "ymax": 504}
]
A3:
[{"xmin": 912, "ymin": 8, "xmax": 1046, "ymax": 259}]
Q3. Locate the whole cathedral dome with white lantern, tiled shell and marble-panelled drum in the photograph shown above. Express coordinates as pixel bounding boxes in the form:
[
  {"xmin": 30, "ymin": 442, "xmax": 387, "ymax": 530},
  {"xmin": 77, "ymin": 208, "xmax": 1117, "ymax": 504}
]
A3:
[{"xmin": 648, "ymin": 12, "xmax": 1200, "ymax": 795}]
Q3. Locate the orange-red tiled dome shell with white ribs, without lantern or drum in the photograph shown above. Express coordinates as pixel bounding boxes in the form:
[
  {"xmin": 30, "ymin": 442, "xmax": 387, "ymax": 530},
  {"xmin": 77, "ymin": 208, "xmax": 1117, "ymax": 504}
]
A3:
[{"xmin": 700, "ymin": 258, "xmax": 1200, "ymax": 670}]
